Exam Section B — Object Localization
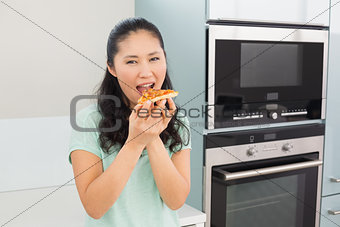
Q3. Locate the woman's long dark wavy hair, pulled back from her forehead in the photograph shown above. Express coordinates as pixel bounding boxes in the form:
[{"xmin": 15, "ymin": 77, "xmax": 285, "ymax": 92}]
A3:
[{"xmin": 96, "ymin": 18, "xmax": 189, "ymax": 153}]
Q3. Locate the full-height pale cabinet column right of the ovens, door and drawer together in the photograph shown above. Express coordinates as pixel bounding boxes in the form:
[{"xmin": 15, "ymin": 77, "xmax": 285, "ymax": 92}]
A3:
[{"xmin": 320, "ymin": 0, "xmax": 340, "ymax": 227}]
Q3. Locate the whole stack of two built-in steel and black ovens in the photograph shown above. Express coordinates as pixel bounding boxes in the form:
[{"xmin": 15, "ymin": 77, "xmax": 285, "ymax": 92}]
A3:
[{"xmin": 203, "ymin": 16, "xmax": 328, "ymax": 227}]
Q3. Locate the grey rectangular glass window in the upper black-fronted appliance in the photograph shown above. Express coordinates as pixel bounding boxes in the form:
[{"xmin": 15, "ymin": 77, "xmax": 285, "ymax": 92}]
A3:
[{"xmin": 240, "ymin": 42, "xmax": 303, "ymax": 88}]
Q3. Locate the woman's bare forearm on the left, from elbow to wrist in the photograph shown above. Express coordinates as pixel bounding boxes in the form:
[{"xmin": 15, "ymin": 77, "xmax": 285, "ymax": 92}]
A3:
[{"xmin": 85, "ymin": 142, "xmax": 143, "ymax": 219}]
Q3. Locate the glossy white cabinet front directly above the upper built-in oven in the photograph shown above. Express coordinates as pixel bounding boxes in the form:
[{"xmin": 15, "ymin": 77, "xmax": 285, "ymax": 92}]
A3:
[{"xmin": 207, "ymin": 0, "xmax": 329, "ymax": 26}]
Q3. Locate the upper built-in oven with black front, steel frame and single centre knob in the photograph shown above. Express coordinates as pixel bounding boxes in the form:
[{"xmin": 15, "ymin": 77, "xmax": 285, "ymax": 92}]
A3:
[{"xmin": 206, "ymin": 20, "xmax": 328, "ymax": 129}]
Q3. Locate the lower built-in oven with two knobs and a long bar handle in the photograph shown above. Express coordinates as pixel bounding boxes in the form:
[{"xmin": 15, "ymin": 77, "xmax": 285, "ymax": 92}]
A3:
[{"xmin": 203, "ymin": 124, "xmax": 325, "ymax": 227}]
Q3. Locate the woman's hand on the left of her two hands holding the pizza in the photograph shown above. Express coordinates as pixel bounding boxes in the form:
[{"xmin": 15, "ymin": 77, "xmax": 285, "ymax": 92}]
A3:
[{"xmin": 127, "ymin": 100, "xmax": 169, "ymax": 146}]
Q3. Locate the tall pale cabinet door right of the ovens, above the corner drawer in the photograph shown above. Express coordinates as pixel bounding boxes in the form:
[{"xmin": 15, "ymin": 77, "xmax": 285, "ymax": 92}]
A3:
[{"xmin": 323, "ymin": 0, "xmax": 340, "ymax": 195}]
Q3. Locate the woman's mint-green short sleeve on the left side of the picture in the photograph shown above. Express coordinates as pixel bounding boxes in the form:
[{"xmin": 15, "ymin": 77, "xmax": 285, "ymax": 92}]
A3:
[{"xmin": 68, "ymin": 107, "xmax": 102, "ymax": 164}]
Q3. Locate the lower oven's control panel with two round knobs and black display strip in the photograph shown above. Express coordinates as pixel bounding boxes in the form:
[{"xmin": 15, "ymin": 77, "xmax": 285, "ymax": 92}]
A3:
[{"xmin": 205, "ymin": 124, "xmax": 325, "ymax": 164}]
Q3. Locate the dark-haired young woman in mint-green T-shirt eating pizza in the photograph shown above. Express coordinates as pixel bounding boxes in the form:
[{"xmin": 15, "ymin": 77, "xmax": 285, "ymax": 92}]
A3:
[{"xmin": 69, "ymin": 18, "xmax": 191, "ymax": 227}]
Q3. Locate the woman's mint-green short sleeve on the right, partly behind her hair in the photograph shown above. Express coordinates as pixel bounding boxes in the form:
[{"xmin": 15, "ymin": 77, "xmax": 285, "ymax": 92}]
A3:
[{"xmin": 174, "ymin": 113, "xmax": 191, "ymax": 152}]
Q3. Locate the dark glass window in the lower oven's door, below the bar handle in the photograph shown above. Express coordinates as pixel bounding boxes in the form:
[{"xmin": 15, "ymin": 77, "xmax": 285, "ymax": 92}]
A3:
[{"xmin": 226, "ymin": 174, "xmax": 306, "ymax": 227}]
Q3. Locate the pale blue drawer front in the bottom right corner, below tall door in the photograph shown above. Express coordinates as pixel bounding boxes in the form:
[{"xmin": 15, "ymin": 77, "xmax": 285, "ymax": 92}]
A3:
[{"xmin": 320, "ymin": 195, "xmax": 340, "ymax": 227}]
